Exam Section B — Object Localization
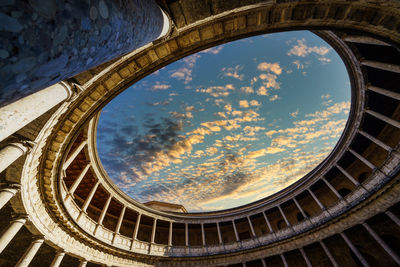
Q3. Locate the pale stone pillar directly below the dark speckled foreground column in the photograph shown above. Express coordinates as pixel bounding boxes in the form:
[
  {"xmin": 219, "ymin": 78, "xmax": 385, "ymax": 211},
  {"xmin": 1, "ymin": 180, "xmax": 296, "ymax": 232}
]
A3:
[{"xmin": 0, "ymin": 82, "xmax": 72, "ymax": 142}]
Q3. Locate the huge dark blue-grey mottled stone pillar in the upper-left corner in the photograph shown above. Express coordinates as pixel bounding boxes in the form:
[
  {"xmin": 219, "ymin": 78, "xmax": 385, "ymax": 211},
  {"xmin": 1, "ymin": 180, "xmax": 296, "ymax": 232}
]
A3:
[{"xmin": 0, "ymin": 0, "xmax": 170, "ymax": 107}]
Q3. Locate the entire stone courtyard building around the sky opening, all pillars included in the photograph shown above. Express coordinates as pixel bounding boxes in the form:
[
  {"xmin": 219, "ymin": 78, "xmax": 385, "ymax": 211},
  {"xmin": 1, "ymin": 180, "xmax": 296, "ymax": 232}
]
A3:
[{"xmin": 0, "ymin": 0, "xmax": 400, "ymax": 266}]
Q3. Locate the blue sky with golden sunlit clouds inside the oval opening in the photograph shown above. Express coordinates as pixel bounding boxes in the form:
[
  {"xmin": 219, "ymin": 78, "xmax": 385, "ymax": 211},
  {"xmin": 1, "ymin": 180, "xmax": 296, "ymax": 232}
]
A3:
[{"xmin": 97, "ymin": 31, "xmax": 350, "ymax": 211}]
